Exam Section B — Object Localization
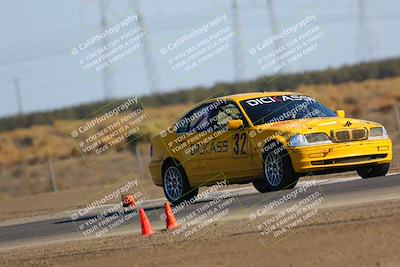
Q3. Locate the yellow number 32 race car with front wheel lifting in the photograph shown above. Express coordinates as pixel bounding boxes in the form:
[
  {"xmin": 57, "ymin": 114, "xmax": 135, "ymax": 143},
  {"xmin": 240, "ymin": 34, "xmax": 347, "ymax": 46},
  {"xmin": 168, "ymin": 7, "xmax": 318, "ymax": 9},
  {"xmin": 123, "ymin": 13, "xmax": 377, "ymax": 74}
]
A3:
[{"xmin": 149, "ymin": 92, "xmax": 392, "ymax": 204}]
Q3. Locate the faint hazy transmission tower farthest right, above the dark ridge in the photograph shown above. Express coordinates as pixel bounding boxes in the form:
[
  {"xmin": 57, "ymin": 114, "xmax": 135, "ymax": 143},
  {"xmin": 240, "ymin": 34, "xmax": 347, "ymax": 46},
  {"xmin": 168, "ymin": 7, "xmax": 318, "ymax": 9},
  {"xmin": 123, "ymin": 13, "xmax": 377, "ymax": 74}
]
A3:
[{"xmin": 357, "ymin": 0, "xmax": 375, "ymax": 58}]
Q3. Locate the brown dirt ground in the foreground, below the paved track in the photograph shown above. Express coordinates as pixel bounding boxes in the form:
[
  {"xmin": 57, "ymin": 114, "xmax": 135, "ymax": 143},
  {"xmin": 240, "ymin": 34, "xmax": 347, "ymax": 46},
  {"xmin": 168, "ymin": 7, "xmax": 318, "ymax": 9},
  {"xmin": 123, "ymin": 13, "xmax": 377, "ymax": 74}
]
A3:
[{"xmin": 0, "ymin": 200, "xmax": 400, "ymax": 267}]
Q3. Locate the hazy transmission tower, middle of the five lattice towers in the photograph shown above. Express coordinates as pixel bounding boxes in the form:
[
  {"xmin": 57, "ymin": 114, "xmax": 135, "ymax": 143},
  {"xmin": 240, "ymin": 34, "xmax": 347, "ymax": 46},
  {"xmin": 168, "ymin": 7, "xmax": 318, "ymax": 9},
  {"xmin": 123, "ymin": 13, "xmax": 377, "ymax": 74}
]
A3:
[{"xmin": 232, "ymin": 0, "xmax": 245, "ymax": 82}]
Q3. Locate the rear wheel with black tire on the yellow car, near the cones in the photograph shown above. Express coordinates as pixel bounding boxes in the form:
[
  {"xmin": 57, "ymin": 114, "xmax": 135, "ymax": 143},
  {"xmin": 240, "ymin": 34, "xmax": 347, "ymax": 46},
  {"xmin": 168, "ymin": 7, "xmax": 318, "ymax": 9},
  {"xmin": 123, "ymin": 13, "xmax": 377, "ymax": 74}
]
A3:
[{"xmin": 162, "ymin": 161, "xmax": 199, "ymax": 205}]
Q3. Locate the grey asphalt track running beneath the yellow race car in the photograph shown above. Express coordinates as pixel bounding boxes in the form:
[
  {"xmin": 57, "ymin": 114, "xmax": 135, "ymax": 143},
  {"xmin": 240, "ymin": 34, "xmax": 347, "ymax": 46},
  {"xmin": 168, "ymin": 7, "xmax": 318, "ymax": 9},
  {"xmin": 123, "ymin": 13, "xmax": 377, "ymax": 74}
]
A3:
[{"xmin": 0, "ymin": 174, "xmax": 400, "ymax": 250}]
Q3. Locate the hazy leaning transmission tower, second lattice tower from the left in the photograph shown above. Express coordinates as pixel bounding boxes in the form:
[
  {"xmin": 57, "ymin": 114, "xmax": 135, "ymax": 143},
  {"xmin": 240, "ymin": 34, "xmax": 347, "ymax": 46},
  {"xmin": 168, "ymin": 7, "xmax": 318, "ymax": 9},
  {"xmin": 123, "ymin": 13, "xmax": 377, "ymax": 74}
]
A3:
[{"xmin": 132, "ymin": 0, "xmax": 159, "ymax": 93}]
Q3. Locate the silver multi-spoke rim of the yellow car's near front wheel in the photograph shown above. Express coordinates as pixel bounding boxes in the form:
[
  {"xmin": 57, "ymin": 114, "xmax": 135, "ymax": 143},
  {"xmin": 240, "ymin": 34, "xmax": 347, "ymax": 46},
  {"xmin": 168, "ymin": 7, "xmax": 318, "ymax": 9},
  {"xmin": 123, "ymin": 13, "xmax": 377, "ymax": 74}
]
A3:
[{"xmin": 264, "ymin": 151, "xmax": 283, "ymax": 186}]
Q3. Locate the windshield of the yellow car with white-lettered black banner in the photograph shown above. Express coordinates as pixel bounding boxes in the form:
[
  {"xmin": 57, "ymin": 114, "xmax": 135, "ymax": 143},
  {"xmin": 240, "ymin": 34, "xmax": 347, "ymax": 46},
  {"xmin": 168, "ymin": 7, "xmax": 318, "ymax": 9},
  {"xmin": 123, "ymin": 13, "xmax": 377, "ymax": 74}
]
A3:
[{"xmin": 240, "ymin": 95, "xmax": 337, "ymax": 125}]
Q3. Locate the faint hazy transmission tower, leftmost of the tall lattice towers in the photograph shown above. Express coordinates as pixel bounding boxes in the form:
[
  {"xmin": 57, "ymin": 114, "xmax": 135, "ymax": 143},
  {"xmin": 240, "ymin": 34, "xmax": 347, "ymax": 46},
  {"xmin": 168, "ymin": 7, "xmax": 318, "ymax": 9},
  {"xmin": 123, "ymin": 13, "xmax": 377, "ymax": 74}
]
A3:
[{"xmin": 99, "ymin": 0, "xmax": 114, "ymax": 100}]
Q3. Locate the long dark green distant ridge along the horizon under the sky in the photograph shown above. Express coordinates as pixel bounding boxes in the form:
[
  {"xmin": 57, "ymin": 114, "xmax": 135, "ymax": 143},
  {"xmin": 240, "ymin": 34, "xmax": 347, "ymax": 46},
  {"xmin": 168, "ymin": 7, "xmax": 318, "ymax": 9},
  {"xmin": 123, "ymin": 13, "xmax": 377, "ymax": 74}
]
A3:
[{"xmin": 0, "ymin": 58, "xmax": 400, "ymax": 131}]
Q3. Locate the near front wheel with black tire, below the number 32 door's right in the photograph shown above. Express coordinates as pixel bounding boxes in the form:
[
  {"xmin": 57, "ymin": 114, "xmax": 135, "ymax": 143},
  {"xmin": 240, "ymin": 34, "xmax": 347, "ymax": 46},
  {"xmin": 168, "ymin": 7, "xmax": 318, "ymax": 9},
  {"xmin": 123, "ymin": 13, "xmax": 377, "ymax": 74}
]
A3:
[{"xmin": 253, "ymin": 142, "xmax": 299, "ymax": 193}]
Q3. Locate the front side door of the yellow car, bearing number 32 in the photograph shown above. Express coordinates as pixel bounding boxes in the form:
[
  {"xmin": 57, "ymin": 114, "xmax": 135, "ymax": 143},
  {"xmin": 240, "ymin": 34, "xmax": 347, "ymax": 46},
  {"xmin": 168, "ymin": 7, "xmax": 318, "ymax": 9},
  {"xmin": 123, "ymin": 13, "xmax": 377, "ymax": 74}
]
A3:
[{"xmin": 210, "ymin": 102, "xmax": 252, "ymax": 179}]
